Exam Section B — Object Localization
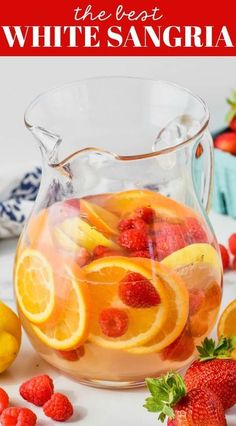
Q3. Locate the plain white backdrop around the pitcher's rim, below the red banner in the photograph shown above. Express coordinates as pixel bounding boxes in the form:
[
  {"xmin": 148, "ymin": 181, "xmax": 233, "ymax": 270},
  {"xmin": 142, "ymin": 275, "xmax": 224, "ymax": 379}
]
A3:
[{"xmin": 0, "ymin": 57, "xmax": 236, "ymax": 171}]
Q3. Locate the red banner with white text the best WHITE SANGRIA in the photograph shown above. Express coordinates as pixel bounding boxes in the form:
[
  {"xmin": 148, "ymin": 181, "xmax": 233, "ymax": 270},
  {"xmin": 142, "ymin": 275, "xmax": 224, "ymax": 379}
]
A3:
[{"xmin": 0, "ymin": 0, "xmax": 236, "ymax": 56}]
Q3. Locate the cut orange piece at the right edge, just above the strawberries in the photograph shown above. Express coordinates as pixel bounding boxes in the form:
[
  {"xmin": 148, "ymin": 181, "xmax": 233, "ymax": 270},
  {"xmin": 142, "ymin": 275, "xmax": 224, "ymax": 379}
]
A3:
[{"xmin": 217, "ymin": 299, "xmax": 236, "ymax": 338}]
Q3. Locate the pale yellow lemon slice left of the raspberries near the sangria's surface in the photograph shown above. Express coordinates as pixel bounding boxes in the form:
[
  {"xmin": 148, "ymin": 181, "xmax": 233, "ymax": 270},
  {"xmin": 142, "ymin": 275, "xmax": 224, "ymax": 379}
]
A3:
[{"xmin": 60, "ymin": 217, "xmax": 118, "ymax": 252}]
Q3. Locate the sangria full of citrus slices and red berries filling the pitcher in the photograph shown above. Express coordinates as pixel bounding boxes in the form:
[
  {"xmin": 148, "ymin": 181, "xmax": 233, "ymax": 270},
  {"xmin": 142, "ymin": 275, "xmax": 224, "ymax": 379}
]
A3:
[{"xmin": 15, "ymin": 189, "xmax": 222, "ymax": 387}]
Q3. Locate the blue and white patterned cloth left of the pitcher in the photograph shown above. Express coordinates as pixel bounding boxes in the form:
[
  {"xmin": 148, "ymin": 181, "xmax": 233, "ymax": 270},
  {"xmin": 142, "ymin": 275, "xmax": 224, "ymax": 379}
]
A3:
[{"xmin": 0, "ymin": 167, "xmax": 41, "ymax": 239}]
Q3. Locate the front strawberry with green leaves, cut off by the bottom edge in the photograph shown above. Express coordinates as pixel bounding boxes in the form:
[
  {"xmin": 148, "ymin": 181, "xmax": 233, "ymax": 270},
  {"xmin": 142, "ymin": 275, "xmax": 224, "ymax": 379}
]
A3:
[{"xmin": 144, "ymin": 373, "xmax": 226, "ymax": 426}]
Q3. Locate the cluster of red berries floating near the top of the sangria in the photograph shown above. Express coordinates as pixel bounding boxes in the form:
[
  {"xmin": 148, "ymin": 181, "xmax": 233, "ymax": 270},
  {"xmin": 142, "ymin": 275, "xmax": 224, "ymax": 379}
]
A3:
[{"xmin": 118, "ymin": 207, "xmax": 208, "ymax": 261}]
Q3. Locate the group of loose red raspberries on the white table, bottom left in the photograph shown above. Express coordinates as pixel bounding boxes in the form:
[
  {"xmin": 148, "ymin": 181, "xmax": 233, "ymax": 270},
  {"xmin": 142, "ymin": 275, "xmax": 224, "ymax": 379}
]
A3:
[{"xmin": 0, "ymin": 374, "xmax": 73, "ymax": 426}]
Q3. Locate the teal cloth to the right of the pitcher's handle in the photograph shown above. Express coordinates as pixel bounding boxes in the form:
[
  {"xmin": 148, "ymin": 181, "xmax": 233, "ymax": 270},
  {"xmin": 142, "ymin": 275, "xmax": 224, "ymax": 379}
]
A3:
[{"xmin": 212, "ymin": 149, "xmax": 236, "ymax": 219}]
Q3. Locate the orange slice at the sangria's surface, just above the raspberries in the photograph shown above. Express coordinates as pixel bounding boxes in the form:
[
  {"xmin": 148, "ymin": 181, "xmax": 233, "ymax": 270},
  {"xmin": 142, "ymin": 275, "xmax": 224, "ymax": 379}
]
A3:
[{"xmin": 104, "ymin": 189, "xmax": 195, "ymax": 220}]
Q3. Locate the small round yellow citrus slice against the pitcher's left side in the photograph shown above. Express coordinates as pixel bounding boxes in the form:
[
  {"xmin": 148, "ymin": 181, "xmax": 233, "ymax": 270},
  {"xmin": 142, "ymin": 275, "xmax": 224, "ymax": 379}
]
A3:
[{"xmin": 15, "ymin": 249, "xmax": 55, "ymax": 324}]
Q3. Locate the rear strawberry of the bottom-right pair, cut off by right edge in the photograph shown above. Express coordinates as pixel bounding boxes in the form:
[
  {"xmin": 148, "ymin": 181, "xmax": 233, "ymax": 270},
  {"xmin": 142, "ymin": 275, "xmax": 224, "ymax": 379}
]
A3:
[{"xmin": 185, "ymin": 337, "xmax": 236, "ymax": 410}]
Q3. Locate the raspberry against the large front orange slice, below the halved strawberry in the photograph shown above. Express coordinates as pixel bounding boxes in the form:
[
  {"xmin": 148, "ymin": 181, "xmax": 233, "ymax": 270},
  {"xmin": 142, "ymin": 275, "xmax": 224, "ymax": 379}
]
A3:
[{"xmin": 99, "ymin": 308, "xmax": 129, "ymax": 337}]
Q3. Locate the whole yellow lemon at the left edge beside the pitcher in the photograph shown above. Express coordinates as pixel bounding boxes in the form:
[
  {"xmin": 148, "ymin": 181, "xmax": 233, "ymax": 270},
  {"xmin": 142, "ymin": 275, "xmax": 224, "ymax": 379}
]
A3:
[{"xmin": 0, "ymin": 301, "xmax": 21, "ymax": 373}]
